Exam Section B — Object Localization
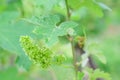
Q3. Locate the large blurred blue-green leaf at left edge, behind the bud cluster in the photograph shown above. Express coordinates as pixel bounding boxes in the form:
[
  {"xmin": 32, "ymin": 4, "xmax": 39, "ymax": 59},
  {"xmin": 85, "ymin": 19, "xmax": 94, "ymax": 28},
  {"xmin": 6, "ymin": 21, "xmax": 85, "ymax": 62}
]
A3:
[{"xmin": 0, "ymin": 12, "xmax": 33, "ymax": 68}]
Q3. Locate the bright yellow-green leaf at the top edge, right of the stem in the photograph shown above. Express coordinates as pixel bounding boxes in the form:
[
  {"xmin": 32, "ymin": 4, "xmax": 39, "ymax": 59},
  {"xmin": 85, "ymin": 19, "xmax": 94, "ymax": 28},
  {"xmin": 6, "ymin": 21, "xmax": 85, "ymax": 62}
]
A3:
[{"xmin": 68, "ymin": 0, "xmax": 106, "ymax": 17}]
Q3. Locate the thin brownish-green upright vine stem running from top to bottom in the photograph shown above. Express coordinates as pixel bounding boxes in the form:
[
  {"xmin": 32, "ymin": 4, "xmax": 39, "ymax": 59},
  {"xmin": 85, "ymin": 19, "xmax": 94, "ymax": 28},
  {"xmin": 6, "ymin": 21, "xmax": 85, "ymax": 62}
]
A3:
[{"xmin": 65, "ymin": 0, "xmax": 78, "ymax": 80}]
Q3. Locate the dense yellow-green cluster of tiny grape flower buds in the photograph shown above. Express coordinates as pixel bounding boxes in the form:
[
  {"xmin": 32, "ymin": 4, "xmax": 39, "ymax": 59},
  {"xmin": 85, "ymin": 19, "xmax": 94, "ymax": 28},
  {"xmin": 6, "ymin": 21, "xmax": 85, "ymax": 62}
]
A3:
[{"xmin": 20, "ymin": 36, "xmax": 52, "ymax": 68}]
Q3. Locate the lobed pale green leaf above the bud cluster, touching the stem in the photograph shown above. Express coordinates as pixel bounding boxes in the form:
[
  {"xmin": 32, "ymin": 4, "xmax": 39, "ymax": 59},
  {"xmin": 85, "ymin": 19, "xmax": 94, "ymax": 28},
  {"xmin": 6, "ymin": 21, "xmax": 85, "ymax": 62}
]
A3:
[{"xmin": 33, "ymin": 15, "xmax": 78, "ymax": 46}]
